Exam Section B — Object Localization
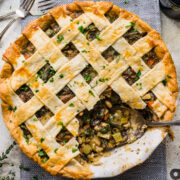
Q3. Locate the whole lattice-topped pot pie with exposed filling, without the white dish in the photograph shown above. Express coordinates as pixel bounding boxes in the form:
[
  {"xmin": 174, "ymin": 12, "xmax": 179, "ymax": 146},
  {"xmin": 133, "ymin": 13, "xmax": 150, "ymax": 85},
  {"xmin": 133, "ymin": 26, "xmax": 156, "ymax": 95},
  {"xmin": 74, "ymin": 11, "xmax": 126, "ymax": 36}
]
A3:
[{"xmin": 0, "ymin": 1, "xmax": 178, "ymax": 179}]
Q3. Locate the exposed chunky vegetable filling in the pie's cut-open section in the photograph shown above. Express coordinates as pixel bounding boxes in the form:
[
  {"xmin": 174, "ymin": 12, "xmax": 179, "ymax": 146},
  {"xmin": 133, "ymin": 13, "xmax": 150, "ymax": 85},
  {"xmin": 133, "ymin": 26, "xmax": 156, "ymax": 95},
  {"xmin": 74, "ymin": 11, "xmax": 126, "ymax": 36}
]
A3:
[{"xmin": 77, "ymin": 87, "xmax": 147, "ymax": 163}]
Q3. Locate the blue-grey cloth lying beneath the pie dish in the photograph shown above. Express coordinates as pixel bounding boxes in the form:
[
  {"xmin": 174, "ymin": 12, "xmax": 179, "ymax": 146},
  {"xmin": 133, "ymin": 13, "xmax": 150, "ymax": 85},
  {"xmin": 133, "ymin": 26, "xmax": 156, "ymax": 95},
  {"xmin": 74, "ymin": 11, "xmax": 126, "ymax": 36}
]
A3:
[{"xmin": 21, "ymin": 0, "xmax": 166, "ymax": 180}]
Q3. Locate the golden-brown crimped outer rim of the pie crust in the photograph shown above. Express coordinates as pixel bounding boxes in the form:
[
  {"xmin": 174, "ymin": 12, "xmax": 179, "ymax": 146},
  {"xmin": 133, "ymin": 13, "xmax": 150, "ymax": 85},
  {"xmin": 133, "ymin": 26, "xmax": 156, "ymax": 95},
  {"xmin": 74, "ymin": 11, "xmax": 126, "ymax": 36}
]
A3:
[{"xmin": 0, "ymin": 1, "xmax": 178, "ymax": 179}]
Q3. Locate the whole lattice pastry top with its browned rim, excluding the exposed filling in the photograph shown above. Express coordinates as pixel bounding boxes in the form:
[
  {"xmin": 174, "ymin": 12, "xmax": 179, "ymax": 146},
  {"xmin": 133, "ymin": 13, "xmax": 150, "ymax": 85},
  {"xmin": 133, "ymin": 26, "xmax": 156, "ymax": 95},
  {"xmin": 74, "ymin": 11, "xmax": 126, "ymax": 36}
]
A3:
[{"xmin": 0, "ymin": 1, "xmax": 178, "ymax": 179}]
